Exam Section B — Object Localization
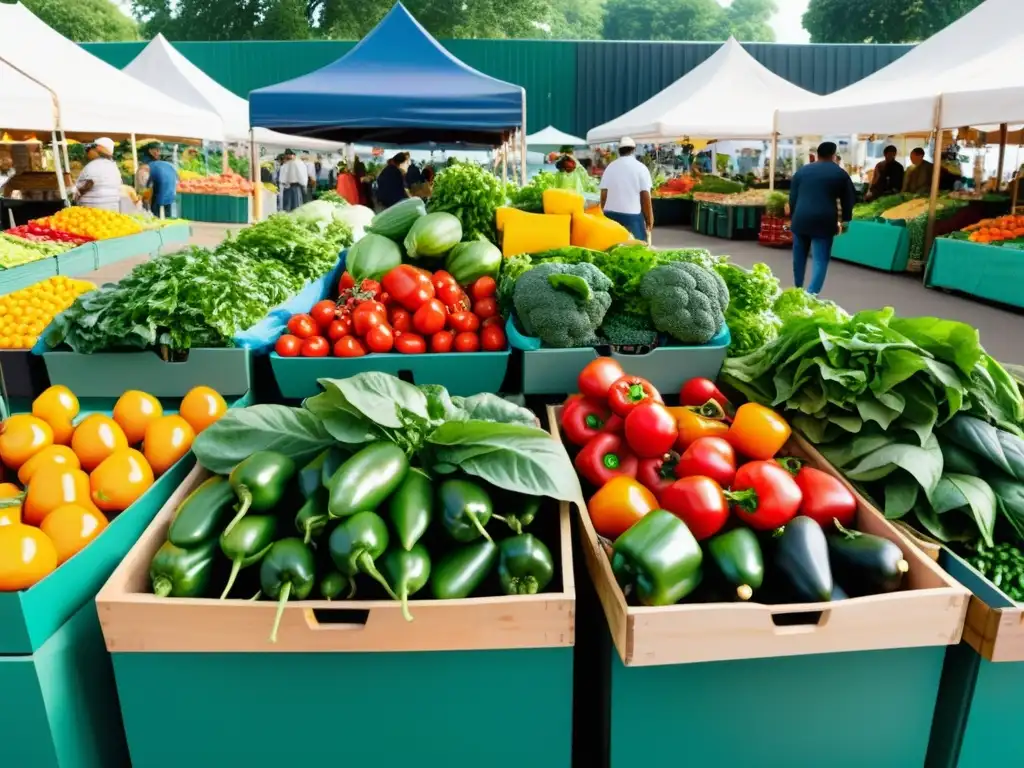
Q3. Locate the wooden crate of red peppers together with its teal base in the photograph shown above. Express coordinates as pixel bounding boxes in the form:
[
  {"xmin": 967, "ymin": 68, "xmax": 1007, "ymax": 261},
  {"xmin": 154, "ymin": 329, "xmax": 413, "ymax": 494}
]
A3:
[{"xmin": 548, "ymin": 408, "xmax": 969, "ymax": 768}]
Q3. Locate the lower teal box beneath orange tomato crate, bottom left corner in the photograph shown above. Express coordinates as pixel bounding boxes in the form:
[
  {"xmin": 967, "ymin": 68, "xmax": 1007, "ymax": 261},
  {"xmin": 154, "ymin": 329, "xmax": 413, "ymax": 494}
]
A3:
[{"xmin": 0, "ymin": 601, "xmax": 129, "ymax": 768}]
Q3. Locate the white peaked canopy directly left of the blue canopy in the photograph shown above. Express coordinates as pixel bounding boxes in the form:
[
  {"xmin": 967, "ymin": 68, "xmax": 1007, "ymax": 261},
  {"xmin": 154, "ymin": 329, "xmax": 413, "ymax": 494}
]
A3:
[{"xmin": 124, "ymin": 35, "xmax": 341, "ymax": 152}]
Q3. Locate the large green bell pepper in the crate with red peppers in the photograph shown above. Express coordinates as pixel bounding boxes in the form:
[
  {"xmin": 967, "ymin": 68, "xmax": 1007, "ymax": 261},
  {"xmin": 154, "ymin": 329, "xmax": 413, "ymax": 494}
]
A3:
[{"xmin": 611, "ymin": 509, "xmax": 703, "ymax": 605}]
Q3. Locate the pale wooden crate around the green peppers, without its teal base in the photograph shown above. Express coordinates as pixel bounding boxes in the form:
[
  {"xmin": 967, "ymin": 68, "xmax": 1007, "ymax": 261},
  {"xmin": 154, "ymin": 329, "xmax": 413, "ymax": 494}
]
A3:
[{"xmin": 96, "ymin": 466, "xmax": 575, "ymax": 653}]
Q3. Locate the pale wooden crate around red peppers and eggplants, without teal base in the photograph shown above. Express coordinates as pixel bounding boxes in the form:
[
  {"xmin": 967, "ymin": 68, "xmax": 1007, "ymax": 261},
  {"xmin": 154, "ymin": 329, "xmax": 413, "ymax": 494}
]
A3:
[{"xmin": 548, "ymin": 406, "xmax": 969, "ymax": 667}]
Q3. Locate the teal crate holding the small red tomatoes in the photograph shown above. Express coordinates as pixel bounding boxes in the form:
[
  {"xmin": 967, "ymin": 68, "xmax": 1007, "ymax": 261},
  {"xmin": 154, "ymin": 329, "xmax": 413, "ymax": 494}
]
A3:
[{"xmin": 270, "ymin": 350, "xmax": 510, "ymax": 399}]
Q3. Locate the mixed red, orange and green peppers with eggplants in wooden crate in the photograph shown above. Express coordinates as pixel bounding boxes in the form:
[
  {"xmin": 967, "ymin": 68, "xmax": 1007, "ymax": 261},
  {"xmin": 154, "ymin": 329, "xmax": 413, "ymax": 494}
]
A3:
[{"xmin": 561, "ymin": 358, "xmax": 909, "ymax": 606}]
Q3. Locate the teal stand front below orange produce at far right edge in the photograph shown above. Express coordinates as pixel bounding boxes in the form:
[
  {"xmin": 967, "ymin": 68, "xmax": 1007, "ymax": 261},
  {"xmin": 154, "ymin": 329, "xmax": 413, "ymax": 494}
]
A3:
[{"xmin": 925, "ymin": 238, "xmax": 1024, "ymax": 307}]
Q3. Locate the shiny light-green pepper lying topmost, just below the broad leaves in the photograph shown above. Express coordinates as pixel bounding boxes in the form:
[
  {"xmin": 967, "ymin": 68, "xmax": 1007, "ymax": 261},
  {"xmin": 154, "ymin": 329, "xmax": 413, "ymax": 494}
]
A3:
[{"xmin": 328, "ymin": 442, "xmax": 409, "ymax": 518}]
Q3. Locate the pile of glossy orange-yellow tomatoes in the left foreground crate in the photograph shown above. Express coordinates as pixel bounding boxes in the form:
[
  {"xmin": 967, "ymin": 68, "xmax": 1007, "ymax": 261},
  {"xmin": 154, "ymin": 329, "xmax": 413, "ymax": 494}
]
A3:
[{"xmin": 0, "ymin": 386, "xmax": 226, "ymax": 592}]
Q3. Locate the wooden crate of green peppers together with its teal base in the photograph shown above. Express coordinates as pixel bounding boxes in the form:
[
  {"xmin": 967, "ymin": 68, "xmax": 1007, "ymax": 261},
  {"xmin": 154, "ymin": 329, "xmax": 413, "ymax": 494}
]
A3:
[{"xmin": 96, "ymin": 468, "xmax": 575, "ymax": 768}]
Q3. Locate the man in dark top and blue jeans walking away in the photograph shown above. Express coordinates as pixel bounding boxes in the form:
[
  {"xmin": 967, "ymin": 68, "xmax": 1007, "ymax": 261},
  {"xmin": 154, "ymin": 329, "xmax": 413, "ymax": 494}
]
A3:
[{"xmin": 790, "ymin": 141, "xmax": 857, "ymax": 294}]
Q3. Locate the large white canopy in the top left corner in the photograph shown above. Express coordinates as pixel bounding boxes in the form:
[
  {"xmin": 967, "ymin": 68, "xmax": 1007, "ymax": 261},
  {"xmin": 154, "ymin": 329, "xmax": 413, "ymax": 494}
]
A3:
[{"xmin": 0, "ymin": 3, "xmax": 224, "ymax": 140}]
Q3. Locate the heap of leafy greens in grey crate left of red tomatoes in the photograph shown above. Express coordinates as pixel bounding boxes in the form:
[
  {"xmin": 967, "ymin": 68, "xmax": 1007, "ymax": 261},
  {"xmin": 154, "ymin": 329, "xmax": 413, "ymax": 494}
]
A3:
[{"xmin": 45, "ymin": 214, "xmax": 352, "ymax": 354}]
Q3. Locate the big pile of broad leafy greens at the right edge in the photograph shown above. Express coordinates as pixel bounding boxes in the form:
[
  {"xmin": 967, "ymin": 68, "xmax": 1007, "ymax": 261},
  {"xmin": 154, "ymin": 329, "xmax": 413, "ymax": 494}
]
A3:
[{"xmin": 722, "ymin": 309, "xmax": 1024, "ymax": 599}]
